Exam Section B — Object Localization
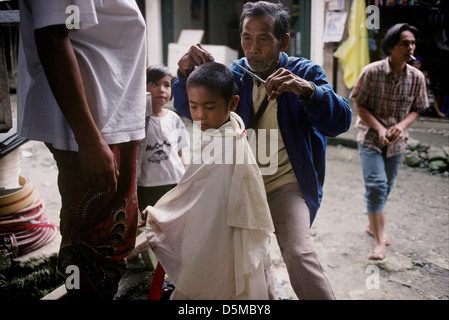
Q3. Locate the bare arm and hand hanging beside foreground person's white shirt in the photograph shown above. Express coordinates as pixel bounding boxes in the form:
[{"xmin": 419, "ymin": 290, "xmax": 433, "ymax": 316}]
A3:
[{"xmin": 35, "ymin": 25, "xmax": 118, "ymax": 192}]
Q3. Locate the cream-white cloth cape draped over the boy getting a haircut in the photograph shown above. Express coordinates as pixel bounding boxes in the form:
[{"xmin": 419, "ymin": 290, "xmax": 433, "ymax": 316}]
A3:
[{"xmin": 146, "ymin": 113, "xmax": 274, "ymax": 300}]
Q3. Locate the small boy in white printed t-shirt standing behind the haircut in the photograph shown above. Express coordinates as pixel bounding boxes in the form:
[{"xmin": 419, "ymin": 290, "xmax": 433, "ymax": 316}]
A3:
[{"xmin": 137, "ymin": 65, "xmax": 189, "ymax": 218}]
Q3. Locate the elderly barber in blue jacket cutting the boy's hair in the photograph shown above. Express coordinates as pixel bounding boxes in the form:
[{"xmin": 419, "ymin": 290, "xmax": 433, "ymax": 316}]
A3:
[{"xmin": 173, "ymin": 1, "xmax": 352, "ymax": 299}]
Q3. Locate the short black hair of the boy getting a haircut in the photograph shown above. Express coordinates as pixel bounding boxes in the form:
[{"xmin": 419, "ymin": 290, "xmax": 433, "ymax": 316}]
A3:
[{"xmin": 187, "ymin": 62, "xmax": 238, "ymax": 103}]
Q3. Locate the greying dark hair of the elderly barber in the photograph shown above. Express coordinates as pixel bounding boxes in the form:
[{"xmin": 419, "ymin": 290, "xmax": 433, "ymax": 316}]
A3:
[{"xmin": 240, "ymin": 1, "xmax": 290, "ymax": 41}]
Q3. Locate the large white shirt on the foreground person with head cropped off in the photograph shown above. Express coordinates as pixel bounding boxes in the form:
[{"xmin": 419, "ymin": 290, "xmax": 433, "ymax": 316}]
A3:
[{"xmin": 18, "ymin": 0, "xmax": 146, "ymax": 151}]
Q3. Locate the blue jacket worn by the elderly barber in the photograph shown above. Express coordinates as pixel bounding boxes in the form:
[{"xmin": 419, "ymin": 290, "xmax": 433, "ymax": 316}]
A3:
[{"xmin": 173, "ymin": 53, "xmax": 352, "ymax": 224}]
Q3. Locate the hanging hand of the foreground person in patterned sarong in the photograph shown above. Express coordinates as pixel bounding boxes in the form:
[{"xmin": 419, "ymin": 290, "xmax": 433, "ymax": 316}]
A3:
[{"xmin": 78, "ymin": 138, "xmax": 119, "ymax": 193}]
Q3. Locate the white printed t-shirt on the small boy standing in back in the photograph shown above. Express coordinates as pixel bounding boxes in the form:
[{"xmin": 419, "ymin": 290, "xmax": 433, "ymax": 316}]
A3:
[{"xmin": 137, "ymin": 110, "xmax": 189, "ymax": 187}]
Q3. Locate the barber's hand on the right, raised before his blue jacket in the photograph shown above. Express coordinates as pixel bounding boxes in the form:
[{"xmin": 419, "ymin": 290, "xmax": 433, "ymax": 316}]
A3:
[{"xmin": 265, "ymin": 68, "xmax": 314, "ymax": 101}]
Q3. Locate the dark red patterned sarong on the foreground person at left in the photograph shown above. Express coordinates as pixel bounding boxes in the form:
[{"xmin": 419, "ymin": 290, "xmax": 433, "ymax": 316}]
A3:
[{"xmin": 49, "ymin": 142, "xmax": 138, "ymax": 299}]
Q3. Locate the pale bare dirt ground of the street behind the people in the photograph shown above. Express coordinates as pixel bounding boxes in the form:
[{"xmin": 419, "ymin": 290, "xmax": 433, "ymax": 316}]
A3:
[{"xmin": 15, "ymin": 142, "xmax": 449, "ymax": 300}]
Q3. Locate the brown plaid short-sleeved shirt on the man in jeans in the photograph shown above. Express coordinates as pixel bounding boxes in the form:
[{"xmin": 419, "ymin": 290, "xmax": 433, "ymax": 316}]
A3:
[{"xmin": 351, "ymin": 57, "xmax": 428, "ymax": 157}]
